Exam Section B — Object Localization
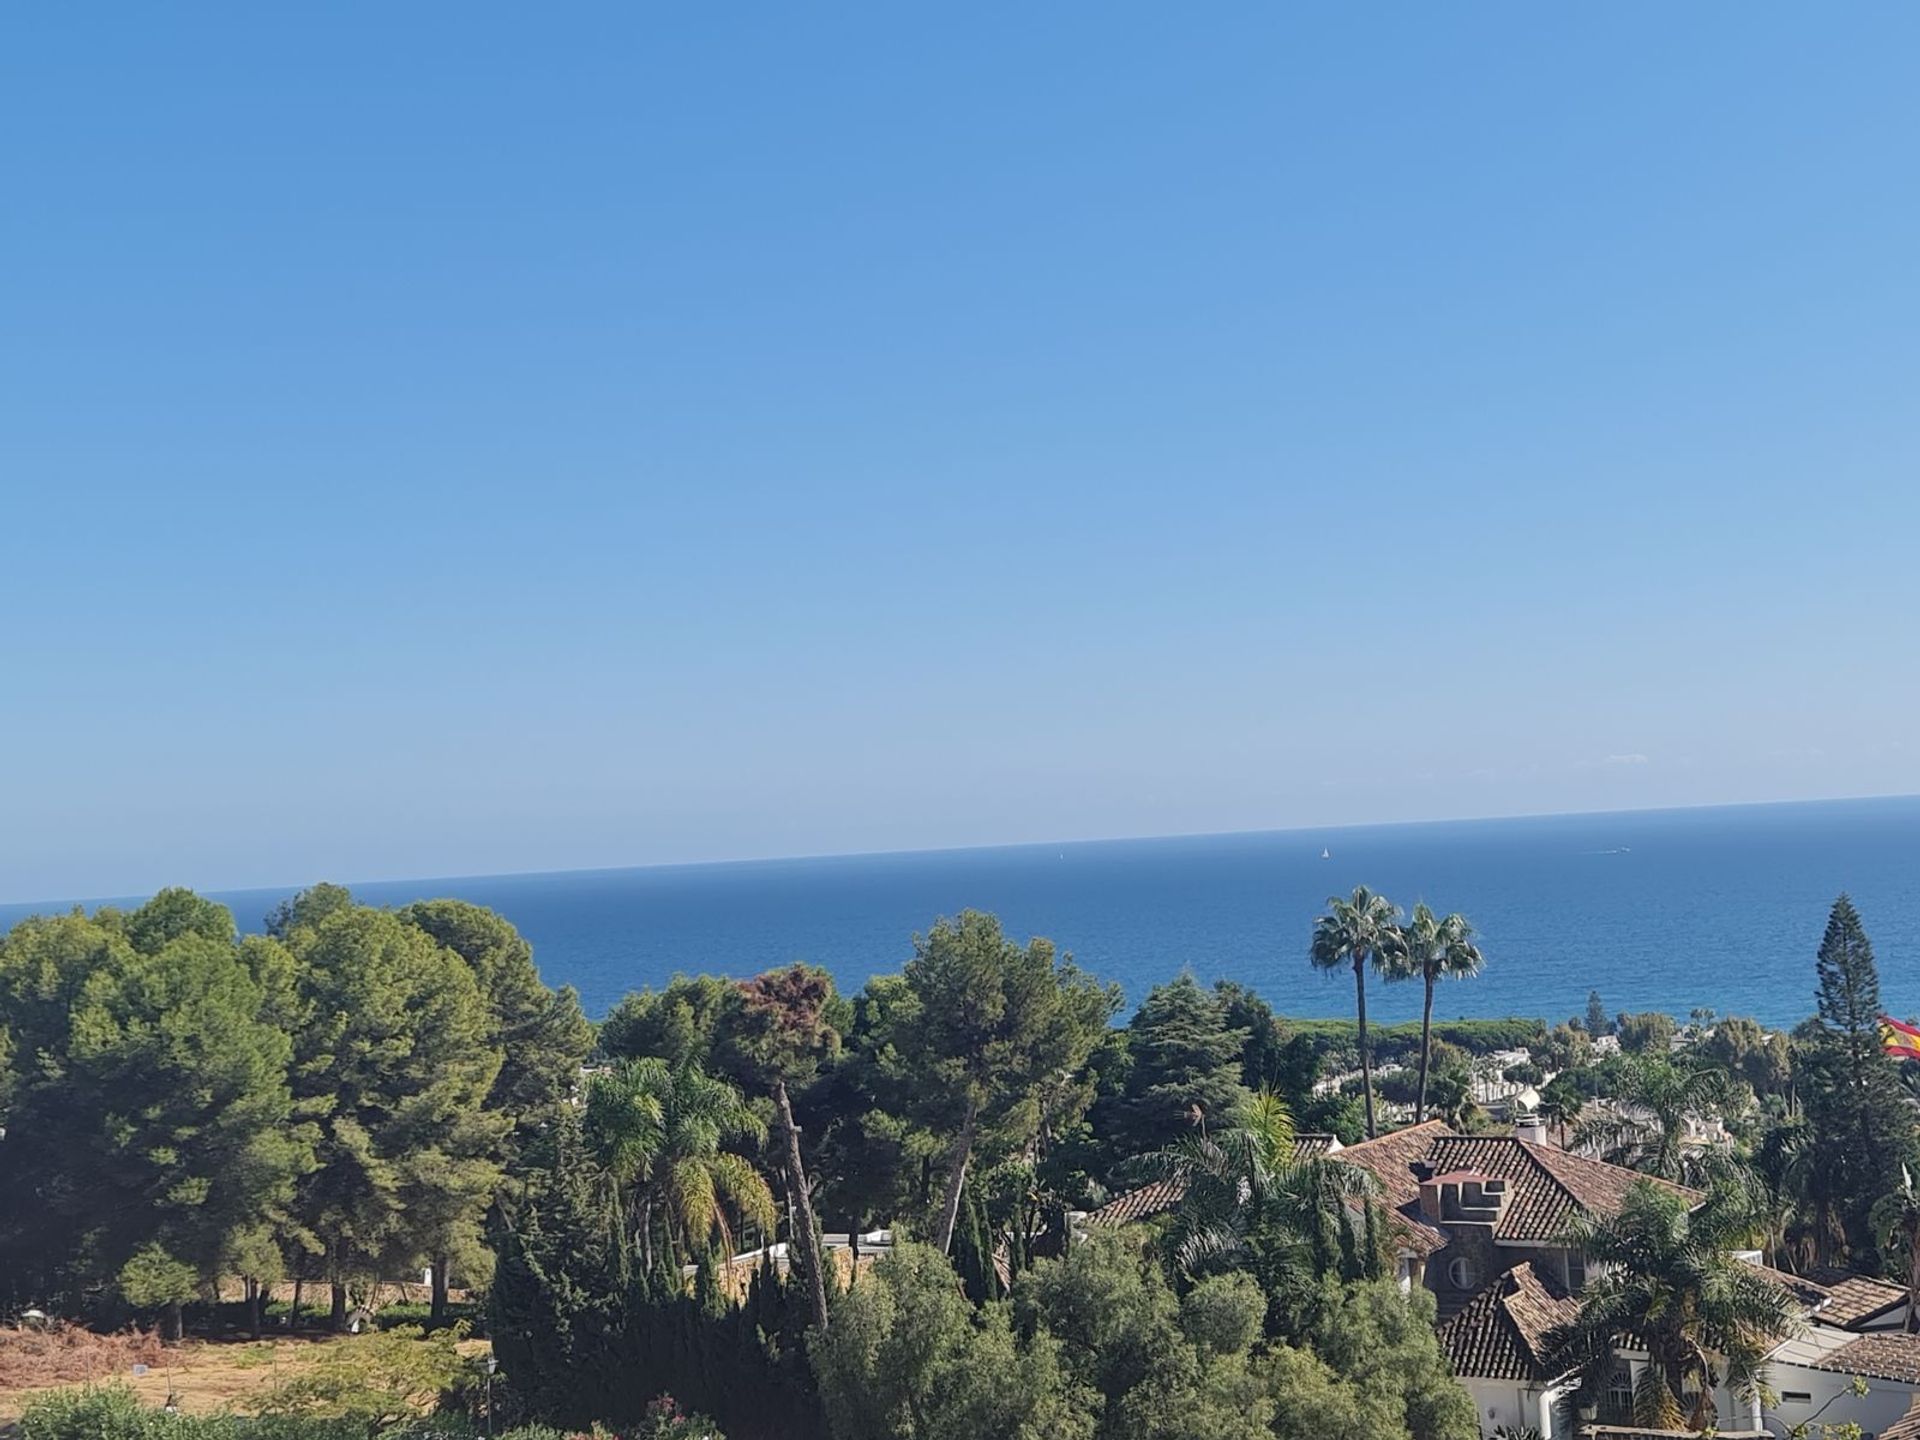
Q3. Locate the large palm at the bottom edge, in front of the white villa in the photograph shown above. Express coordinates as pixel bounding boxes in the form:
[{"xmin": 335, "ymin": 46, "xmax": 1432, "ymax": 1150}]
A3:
[{"xmin": 1548, "ymin": 1181, "xmax": 1799, "ymax": 1430}]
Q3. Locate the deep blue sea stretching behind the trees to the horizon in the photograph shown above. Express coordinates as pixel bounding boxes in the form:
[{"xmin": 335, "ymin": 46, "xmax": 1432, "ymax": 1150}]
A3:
[{"xmin": 0, "ymin": 797, "xmax": 1920, "ymax": 1023}]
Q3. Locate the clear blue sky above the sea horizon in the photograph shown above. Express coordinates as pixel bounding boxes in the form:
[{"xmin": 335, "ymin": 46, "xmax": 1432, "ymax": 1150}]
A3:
[{"xmin": 0, "ymin": 2, "xmax": 1920, "ymax": 899}]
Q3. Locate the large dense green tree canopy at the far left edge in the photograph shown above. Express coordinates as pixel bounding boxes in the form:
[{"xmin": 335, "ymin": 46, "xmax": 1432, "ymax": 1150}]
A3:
[{"xmin": 0, "ymin": 891, "xmax": 313, "ymax": 1320}]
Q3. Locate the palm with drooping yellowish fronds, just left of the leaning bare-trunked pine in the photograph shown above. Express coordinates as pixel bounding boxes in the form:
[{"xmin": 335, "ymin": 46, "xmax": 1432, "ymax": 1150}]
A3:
[{"xmin": 586, "ymin": 1056, "xmax": 774, "ymax": 1267}]
